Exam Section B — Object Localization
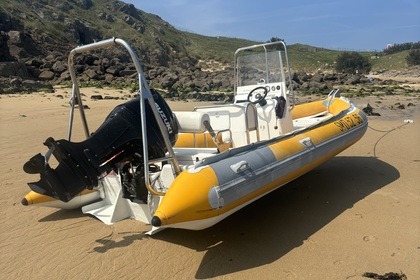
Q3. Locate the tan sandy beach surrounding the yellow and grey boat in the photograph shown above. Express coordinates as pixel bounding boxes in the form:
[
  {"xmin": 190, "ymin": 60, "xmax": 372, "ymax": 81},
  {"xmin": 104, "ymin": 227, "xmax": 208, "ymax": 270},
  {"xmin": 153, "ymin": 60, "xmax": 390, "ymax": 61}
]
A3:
[{"xmin": 0, "ymin": 86, "xmax": 420, "ymax": 279}]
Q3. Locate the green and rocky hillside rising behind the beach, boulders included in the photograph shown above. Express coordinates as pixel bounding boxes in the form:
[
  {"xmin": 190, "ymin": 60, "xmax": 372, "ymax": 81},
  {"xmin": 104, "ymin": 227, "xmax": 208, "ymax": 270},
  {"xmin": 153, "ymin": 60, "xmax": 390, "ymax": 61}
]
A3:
[{"xmin": 0, "ymin": 0, "xmax": 414, "ymax": 95}]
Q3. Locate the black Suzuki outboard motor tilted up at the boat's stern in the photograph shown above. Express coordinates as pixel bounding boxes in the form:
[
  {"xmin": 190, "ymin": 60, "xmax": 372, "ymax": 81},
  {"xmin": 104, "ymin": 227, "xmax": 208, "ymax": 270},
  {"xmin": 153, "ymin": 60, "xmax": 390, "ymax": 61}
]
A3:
[{"xmin": 23, "ymin": 91, "xmax": 178, "ymax": 202}]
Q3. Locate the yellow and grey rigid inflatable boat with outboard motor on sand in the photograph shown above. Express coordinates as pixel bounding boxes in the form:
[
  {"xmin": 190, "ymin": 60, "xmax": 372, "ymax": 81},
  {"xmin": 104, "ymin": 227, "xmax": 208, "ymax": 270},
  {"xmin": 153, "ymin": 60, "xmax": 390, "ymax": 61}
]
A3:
[{"xmin": 22, "ymin": 38, "xmax": 367, "ymax": 234}]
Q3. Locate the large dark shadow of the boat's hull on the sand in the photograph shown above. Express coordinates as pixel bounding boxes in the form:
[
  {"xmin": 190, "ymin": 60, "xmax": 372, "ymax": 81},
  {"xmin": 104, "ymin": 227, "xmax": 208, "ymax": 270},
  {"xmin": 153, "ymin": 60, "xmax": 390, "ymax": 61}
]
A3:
[{"xmin": 153, "ymin": 157, "xmax": 400, "ymax": 279}]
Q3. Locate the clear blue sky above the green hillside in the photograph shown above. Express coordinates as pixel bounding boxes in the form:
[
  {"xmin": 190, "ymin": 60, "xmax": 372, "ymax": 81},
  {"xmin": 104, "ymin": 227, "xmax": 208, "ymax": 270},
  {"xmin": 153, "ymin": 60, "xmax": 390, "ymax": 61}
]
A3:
[{"xmin": 123, "ymin": 0, "xmax": 420, "ymax": 50}]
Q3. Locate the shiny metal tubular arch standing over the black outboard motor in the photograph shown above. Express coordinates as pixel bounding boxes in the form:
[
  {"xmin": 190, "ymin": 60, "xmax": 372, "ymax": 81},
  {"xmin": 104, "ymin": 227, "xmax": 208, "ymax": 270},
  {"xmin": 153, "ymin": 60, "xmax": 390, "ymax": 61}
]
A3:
[{"xmin": 67, "ymin": 38, "xmax": 181, "ymax": 196}]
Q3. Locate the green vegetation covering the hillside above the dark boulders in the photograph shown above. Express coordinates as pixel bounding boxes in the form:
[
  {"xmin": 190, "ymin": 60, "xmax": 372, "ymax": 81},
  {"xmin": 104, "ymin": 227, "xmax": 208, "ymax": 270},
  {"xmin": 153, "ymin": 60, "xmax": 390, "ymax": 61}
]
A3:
[{"xmin": 0, "ymin": 0, "xmax": 420, "ymax": 73}]
